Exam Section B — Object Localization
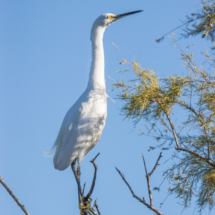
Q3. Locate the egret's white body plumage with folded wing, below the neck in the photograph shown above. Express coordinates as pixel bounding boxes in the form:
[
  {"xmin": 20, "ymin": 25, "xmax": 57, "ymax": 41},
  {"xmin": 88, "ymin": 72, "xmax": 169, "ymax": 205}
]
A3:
[{"xmin": 54, "ymin": 87, "xmax": 107, "ymax": 170}]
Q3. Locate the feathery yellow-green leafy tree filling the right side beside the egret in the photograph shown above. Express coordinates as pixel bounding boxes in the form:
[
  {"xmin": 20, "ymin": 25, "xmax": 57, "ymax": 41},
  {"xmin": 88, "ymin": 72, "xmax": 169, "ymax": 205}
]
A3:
[{"xmin": 113, "ymin": 1, "xmax": 215, "ymax": 214}]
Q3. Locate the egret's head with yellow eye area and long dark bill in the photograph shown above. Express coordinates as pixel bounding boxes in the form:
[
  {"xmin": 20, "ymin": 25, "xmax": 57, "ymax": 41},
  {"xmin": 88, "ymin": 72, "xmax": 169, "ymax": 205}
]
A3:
[{"xmin": 94, "ymin": 10, "xmax": 142, "ymax": 28}]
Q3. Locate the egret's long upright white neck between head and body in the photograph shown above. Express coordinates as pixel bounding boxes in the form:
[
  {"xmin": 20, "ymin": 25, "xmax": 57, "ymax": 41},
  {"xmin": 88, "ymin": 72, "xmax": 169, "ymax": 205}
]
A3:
[{"xmin": 88, "ymin": 26, "xmax": 105, "ymax": 90}]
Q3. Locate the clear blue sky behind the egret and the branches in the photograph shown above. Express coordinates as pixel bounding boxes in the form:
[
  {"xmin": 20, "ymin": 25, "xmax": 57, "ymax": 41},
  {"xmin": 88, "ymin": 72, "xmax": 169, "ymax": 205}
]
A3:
[{"xmin": 0, "ymin": 0, "xmax": 212, "ymax": 215}]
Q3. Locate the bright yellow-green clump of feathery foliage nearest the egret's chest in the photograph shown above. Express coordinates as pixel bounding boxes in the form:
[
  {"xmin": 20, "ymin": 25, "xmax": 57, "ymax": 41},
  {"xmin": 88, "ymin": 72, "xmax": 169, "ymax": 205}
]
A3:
[{"xmin": 114, "ymin": 62, "xmax": 191, "ymax": 122}]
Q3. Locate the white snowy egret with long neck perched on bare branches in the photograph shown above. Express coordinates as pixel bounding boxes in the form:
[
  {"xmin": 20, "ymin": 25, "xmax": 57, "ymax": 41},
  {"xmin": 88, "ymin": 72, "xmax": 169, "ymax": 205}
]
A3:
[{"xmin": 53, "ymin": 10, "xmax": 142, "ymax": 213}]
